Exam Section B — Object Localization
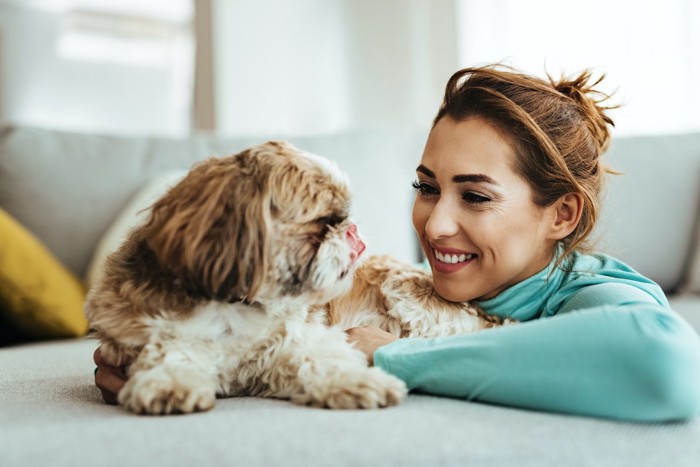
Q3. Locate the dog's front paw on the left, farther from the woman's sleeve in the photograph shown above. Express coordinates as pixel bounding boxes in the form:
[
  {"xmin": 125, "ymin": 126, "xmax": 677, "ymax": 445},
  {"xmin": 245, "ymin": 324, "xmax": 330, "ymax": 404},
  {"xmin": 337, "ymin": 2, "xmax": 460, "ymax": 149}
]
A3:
[{"xmin": 119, "ymin": 369, "xmax": 216, "ymax": 415}]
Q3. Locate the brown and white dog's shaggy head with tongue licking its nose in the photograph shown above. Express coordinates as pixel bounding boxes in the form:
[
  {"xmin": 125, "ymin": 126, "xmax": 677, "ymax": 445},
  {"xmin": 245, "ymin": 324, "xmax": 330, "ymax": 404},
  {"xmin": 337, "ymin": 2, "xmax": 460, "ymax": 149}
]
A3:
[{"xmin": 138, "ymin": 142, "xmax": 364, "ymax": 303}]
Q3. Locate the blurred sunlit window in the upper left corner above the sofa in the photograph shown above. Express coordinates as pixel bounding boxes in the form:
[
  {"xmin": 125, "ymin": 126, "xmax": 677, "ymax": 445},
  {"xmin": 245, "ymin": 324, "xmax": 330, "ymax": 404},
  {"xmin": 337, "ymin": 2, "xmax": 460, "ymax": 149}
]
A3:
[{"xmin": 0, "ymin": 0, "xmax": 194, "ymax": 135}]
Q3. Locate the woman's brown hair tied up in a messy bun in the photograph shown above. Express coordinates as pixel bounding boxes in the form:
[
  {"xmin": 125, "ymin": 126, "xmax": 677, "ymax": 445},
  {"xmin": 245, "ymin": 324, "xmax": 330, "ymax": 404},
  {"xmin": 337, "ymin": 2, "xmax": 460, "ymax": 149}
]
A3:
[{"xmin": 433, "ymin": 65, "xmax": 616, "ymax": 265}]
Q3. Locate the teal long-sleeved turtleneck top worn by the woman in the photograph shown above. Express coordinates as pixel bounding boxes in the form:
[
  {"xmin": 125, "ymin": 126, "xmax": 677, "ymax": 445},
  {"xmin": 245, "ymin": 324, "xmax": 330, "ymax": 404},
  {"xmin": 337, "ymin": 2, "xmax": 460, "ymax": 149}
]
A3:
[{"xmin": 374, "ymin": 254, "xmax": 700, "ymax": 421}]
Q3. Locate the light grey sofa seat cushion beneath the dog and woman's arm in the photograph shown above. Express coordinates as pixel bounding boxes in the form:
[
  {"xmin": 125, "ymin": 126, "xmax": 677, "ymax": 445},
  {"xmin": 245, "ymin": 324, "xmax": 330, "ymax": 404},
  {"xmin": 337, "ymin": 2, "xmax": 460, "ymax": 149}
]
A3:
[{"xmin": 0, "ymin": 340, "xmax": 700, "ymax": 467}]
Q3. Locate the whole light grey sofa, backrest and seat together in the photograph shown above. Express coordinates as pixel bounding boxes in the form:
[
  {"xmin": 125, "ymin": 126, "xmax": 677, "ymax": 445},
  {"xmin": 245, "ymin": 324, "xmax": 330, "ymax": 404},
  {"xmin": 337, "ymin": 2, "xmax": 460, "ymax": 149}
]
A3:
[{"xmin": 0, "ymin": 127, "xmax": 700, "ymax": 467}]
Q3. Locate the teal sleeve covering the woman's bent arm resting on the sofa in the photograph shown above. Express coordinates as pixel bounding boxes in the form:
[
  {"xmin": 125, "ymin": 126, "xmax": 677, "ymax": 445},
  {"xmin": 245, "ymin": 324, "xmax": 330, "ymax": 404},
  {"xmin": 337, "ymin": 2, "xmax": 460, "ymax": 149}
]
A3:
[{"xmin": 374, "ymin": 303, "xmax": 700, "ymax": 421}]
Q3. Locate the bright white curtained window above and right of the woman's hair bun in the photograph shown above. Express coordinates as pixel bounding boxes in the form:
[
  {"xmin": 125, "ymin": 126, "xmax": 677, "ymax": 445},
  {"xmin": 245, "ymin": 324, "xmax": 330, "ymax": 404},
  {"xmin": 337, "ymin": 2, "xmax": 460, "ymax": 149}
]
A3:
[{"xmin": 456, "ymin": 0, "xmax": 700, "ymax": 135}]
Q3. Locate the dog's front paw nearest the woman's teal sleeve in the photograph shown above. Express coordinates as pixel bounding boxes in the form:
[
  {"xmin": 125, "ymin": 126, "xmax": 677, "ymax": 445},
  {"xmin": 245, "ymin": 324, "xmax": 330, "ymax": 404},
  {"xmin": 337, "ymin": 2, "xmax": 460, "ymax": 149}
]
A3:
[{"xmin": 292, "ymin": 368, "xmax": 408, "ymax": 409}]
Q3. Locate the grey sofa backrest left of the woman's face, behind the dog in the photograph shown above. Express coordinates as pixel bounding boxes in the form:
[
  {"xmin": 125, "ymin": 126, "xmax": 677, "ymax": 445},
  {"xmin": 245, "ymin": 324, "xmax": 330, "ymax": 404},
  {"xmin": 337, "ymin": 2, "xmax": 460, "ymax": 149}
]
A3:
[{"xmin": 0, "ymin": 127, "xmax": 425, "ymax": 284}]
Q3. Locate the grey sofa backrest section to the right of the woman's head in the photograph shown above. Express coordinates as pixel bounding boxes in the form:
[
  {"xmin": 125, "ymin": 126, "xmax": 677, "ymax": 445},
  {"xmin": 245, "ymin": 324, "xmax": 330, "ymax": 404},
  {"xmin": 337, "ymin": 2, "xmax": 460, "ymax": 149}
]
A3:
[{"xmin": 594, "ymin": 133, "xmax": 700, "ymax": 291}]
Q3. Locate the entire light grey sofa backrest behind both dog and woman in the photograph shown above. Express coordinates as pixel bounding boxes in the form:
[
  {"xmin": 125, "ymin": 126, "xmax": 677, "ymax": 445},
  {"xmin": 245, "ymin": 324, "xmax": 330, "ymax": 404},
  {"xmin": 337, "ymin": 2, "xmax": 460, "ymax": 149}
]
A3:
[{"xmin": 0, "ymin": 127, "xmax": 700, "ymax": 291}]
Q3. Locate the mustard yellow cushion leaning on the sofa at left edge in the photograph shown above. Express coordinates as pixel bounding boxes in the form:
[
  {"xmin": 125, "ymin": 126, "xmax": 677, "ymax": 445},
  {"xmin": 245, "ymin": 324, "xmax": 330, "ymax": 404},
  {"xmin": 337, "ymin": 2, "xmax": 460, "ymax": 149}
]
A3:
[{"xmin": 0, "ymin": 209, "xmax": 88, "ymax": 338}]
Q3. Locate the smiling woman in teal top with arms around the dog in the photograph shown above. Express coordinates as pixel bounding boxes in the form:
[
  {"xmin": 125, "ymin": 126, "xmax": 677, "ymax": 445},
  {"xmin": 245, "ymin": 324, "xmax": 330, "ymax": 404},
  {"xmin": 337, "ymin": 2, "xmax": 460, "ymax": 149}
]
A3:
[{"xmin": 95, "ymin": 67, "xmax": 700, "ymax": 421}]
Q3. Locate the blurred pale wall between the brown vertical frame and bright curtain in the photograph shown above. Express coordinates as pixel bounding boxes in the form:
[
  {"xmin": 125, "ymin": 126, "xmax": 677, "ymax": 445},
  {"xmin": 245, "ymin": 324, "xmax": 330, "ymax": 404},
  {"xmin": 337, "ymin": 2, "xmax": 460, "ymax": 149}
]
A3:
[{"xmin": 213, "ymin": 0, "xmax": 458, "ymax": 134}]
